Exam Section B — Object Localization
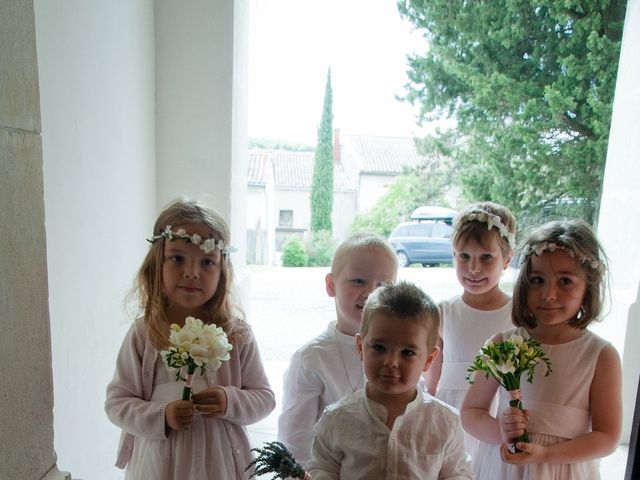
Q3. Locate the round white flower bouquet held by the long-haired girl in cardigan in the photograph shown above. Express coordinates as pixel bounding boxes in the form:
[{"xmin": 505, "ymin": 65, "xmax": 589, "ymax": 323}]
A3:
[{"xmin": 161, "ymin": 317, "xmax": 233, "ymax": 400}]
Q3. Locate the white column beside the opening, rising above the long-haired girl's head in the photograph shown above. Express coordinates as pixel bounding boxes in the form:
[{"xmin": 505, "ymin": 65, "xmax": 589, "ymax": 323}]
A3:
[{"xmin": 155, "ymin": 0, "xmax": 249, "ymax": 267}]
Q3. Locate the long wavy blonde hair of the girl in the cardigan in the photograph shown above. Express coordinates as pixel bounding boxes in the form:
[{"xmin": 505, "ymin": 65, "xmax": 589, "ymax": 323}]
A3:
[{"xmin": 133, "ymin": 197, "xmax": 246, "ymax": 349}]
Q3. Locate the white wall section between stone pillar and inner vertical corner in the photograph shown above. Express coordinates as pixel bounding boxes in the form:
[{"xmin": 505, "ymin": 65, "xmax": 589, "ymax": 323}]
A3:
[{"xmin": 35, "ymin": 0, "xmax": 156, "ymax": 479}]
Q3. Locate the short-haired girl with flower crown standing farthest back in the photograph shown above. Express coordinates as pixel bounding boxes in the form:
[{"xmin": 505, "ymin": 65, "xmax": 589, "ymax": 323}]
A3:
[{"xmin": 425, "ymin": 202, "xmax": 516, "ymax": 457}]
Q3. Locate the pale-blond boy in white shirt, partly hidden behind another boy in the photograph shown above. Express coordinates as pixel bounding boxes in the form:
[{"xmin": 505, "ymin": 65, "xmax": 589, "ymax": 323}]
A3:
[{"xmin": 278, "ymin": 233, "xmax": 398, "ymax": 466}]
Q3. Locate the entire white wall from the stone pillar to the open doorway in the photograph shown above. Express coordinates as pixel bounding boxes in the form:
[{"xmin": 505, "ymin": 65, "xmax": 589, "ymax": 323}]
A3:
[{"xmin": 35, "ymin": 0, "xmax": 248, "ymax": 480}]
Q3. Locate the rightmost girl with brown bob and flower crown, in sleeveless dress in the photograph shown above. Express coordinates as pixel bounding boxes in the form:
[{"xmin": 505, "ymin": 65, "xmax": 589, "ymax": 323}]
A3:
[{"xmin": 461, "ymin": 220, "xmax": 622, "ymax": 480}]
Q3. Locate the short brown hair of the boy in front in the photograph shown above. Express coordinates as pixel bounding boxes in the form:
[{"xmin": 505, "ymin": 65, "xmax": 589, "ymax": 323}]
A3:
[{"xmin": 360, "ymin": 280, "xmax": 440, "ymax": 351}]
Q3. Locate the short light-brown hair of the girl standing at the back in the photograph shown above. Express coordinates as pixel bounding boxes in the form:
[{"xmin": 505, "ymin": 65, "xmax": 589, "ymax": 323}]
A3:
[{"xmin": 451, "ymin": 202, "xmax": 517, "ymax": 258}]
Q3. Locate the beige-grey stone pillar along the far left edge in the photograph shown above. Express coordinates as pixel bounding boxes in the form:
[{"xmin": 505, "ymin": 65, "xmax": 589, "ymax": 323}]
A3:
[{"xmin": 0, "ymin": 0, "xmax": 69, "ymax": 480}]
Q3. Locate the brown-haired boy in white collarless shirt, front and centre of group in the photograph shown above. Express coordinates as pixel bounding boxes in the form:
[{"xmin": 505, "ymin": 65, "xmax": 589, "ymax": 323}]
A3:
[{"xmin": 307, "ymin": 282, "xmax": 474, "ymax": 480}]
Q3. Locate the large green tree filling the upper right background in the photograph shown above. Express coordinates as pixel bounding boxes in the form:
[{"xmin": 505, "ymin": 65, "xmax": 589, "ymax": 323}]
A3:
[{"xmin": 398, "ymin": 0, "xmax": 626, "ymax": 223}]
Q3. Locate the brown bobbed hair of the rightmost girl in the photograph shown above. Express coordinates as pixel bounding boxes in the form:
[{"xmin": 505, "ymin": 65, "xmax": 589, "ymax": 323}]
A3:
[{"xmin": 511, "ymin": 219, "xmax": 607, "ymax": 329}]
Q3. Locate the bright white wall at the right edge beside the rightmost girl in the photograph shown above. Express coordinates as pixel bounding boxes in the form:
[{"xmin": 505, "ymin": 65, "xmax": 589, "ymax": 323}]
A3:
[{"xmin": 594, "ymin": 0, "xmax": 640, "ymax": 442}]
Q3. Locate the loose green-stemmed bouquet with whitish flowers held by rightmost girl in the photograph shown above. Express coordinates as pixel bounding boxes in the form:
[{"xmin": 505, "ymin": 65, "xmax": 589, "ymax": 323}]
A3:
[{"xmin": 466, "ymin": 335, "xmax": 551, "ymax": 451}]
